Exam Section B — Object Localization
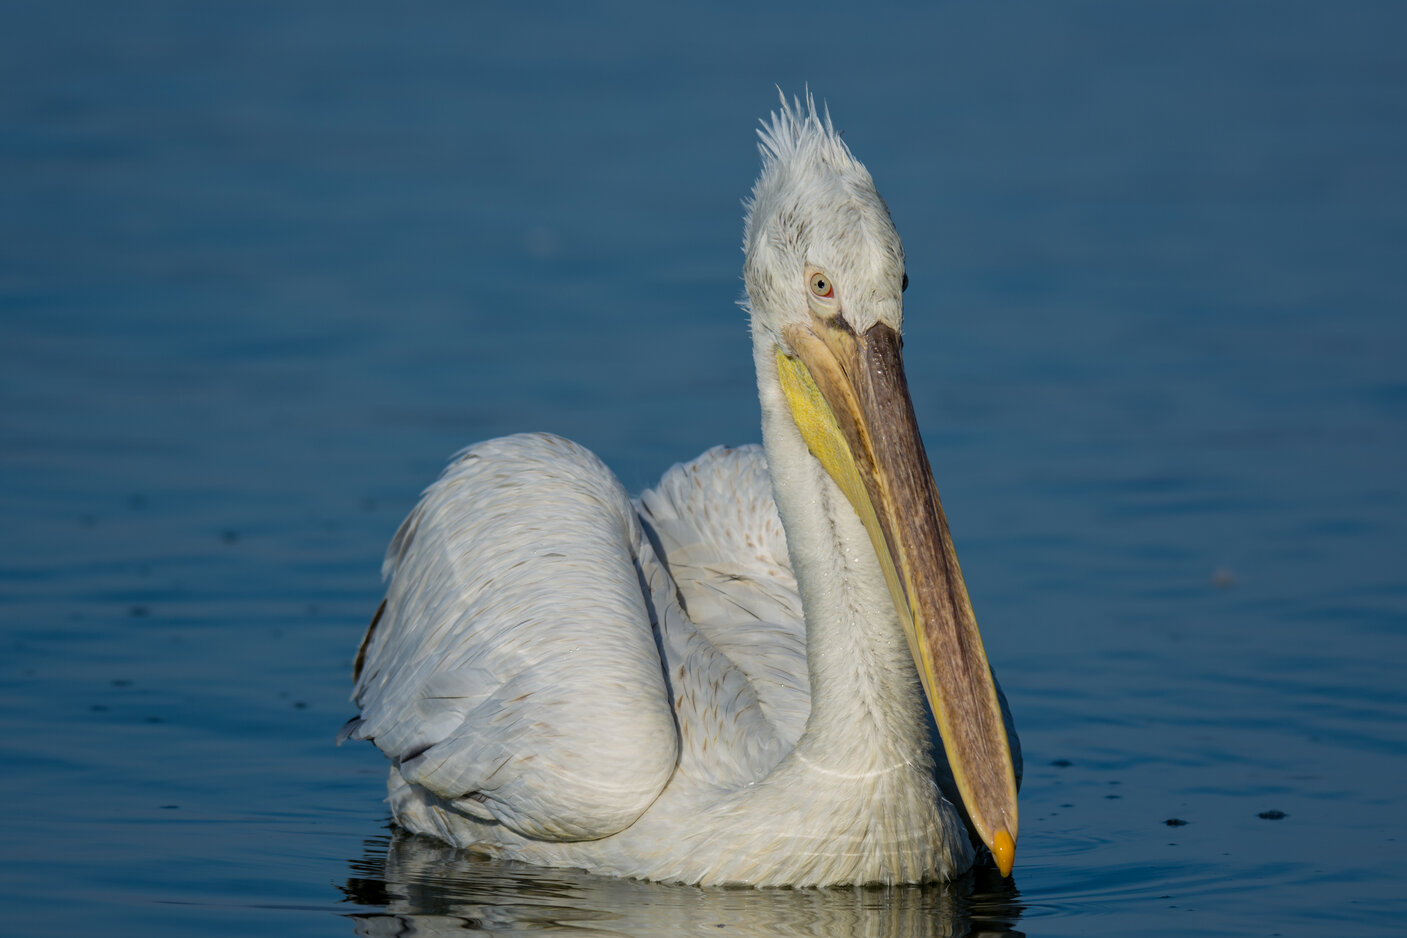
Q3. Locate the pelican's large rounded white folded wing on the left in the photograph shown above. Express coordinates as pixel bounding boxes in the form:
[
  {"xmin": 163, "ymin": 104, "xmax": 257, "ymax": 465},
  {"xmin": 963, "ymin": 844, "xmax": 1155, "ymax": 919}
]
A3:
[{"xmin": 348, "ymin": 435, "xmax": 680, "ymax": 841}]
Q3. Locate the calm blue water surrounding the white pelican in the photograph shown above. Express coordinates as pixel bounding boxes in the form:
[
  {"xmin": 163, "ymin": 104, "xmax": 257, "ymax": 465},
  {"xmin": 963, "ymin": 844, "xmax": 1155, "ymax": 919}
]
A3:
[{"xmin": 0, "ymin": 0, "xmax": 1407, "ymax": 935}]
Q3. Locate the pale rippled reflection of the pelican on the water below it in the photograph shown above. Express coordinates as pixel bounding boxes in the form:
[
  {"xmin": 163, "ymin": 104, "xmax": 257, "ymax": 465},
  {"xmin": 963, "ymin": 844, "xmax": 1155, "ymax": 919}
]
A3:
[{"xmin": 343, "ymin": 831, "xmax": 1021, "ymax": 938}]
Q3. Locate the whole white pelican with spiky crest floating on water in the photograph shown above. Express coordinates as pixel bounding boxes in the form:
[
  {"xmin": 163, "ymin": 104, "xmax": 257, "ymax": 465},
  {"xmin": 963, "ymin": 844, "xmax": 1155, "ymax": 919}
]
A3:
[{"xmin": 342, "ymin": 91, "xmax": 1020, "ymax": 886}]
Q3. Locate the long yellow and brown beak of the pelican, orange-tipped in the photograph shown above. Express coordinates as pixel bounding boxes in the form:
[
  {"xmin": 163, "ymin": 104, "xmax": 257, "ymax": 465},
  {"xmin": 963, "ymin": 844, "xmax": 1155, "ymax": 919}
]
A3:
[{"xmin": 777, "ymin": 315, "xmax": 1017, "ymax": 876}]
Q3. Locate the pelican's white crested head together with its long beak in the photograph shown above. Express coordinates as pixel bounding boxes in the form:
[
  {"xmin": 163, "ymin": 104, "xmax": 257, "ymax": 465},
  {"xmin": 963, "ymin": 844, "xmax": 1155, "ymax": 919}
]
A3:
[{"xmin": 744, "ymin": 94, "xmax": 1017, "ymax": 875}]
